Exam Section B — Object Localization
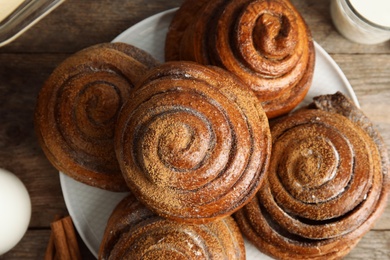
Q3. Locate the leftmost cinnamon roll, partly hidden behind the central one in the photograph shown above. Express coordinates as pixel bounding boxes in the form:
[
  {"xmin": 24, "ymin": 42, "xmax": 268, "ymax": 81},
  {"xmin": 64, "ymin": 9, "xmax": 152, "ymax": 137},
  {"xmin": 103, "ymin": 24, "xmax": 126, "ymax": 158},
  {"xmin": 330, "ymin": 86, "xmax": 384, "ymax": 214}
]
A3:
[{"xmin": 35, "ymin": 43, "xmax": 158, "ymax": 191}]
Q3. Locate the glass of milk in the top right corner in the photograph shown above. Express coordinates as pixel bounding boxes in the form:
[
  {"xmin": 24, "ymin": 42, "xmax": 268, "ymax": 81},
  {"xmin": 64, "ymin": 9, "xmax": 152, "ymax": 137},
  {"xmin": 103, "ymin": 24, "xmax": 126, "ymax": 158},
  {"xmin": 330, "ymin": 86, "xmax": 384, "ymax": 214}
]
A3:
[{"xmin": 330, "ymin": 0, "xmax": 390, "ymax": 44}]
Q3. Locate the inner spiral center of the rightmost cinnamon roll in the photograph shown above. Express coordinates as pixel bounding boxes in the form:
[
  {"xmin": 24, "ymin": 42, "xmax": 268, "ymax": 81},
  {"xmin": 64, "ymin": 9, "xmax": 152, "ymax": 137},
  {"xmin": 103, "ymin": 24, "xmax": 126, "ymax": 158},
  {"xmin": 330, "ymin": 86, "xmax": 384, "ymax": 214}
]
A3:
[{"xmin": 271, "ymin": 123, "xmax": 353, "ymax": 203}]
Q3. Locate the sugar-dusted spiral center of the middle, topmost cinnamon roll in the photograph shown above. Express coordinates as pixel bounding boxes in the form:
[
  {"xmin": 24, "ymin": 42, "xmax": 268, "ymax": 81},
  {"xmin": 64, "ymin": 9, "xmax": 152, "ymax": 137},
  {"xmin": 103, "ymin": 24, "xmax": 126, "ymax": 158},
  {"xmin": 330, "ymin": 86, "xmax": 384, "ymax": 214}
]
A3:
[{"xmin": 139, "ymin": 107, "xmax": 214, "ymax": 188}]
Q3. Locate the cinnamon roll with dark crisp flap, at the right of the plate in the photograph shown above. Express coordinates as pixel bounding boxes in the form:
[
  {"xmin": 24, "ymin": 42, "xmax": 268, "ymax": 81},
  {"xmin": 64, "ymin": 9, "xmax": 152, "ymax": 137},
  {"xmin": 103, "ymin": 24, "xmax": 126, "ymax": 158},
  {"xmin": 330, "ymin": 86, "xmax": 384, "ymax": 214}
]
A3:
[{"xmin": 235, "ymin": 93, "xmax": 390, "ymax": 259}]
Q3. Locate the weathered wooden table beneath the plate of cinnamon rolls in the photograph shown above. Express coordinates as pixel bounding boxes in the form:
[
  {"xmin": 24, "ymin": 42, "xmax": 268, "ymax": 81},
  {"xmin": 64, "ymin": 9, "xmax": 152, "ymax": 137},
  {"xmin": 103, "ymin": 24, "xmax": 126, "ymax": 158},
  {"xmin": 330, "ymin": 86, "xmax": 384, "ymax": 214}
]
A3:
[{"xmin": 0, "ymin": 0, "xmax": 390, "ymax": 259}]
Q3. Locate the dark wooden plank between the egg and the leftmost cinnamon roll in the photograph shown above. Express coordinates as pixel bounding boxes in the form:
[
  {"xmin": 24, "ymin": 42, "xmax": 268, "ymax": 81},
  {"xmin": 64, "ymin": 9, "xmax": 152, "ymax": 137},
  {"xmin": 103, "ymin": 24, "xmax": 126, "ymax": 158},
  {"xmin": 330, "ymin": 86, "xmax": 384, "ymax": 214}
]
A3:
[{"xmin": 0, "ymin": 54, "xmax": 67, "ymax": 228}]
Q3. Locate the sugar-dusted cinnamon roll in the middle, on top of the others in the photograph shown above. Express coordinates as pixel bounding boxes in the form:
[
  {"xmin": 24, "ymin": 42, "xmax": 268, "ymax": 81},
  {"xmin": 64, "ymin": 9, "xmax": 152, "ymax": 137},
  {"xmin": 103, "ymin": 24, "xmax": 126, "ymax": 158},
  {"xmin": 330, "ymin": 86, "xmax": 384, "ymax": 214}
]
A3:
[{"xmin": 115, "ymin": 62, "xmax": 271, "ymax": 223}]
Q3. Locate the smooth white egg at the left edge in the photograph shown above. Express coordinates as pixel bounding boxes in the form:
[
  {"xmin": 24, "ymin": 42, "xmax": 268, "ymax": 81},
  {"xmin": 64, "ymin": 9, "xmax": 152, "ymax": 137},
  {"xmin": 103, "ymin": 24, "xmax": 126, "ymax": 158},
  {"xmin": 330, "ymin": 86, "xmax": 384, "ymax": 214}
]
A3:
[{"xmin": 0, "ymin": 169, "xmax": 31, "ymax": 255}]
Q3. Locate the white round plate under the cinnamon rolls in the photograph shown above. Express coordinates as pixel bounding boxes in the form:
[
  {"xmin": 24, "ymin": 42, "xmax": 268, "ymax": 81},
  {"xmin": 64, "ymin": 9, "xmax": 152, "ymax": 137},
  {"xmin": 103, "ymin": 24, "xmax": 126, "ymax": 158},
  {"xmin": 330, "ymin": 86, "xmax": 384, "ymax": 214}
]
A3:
[{"xmin": 60, "ymin": 9, "xmax": 359, "ymax": 259}]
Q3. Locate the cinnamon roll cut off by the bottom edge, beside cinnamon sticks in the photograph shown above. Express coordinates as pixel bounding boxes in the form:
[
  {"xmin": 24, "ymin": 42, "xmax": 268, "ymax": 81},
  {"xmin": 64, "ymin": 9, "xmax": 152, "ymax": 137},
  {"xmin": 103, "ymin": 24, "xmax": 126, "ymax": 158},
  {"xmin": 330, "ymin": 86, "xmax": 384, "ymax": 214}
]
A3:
[{"xmin": 98, "ymin": 194, "xmax": 245, "ymax": 260}]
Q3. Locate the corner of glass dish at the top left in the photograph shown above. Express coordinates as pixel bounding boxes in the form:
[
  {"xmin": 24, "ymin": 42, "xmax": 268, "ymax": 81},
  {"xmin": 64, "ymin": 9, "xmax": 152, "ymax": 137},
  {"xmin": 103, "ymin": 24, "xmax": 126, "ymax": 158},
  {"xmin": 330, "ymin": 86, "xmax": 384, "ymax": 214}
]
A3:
[{"xmin": 0, "ymin": 0, "xmax": 65, "ymax": 46}]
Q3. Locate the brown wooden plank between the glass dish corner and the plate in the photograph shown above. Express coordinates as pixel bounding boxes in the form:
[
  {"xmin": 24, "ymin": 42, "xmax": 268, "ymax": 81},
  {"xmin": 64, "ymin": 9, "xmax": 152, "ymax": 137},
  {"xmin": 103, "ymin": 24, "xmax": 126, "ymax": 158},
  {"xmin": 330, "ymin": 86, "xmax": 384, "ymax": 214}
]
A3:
[{"xmin": 0, "ymin": 0, "xmax": 183, "ymax": 53}]
